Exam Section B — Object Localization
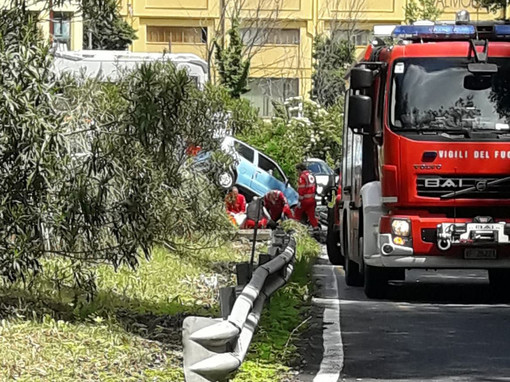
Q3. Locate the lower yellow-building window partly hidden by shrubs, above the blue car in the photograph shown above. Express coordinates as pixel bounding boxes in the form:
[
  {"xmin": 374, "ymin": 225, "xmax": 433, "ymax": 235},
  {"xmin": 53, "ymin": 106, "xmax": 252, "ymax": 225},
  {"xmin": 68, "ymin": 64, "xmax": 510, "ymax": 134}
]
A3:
[{"xmin": 243, "ymin": 78, "xmax": 299, "ymax": 117}]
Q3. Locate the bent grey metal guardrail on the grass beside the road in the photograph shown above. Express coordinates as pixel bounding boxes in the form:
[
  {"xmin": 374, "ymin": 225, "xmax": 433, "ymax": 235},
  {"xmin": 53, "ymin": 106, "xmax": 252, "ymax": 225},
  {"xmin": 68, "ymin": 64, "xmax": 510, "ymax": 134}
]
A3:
[{"xmin": 183, "ymin": 234, "xmax": 296, "ymax": 382}]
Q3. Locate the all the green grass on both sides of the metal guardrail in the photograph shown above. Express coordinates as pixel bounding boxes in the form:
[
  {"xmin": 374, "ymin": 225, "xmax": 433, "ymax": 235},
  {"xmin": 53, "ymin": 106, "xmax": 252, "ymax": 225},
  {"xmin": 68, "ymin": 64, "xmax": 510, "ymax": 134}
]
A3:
[{"xmin": 0, "ymin": 225, "xmax": 317, "ymax": 382}]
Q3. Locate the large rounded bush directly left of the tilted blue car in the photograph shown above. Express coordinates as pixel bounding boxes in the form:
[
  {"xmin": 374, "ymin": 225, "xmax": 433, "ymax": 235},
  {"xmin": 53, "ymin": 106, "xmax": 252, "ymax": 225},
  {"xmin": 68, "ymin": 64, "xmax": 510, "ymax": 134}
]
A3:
[{"xmin": 53, "ymin": 62, "xmax": 233, "ymax": 284}]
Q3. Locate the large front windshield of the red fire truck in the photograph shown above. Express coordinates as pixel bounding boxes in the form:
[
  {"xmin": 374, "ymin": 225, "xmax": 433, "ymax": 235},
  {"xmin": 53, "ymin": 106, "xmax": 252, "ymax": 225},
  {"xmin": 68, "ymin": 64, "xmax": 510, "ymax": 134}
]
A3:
[{"xmin": 390, "ymin": 57, "xmax": 510, "ymax": 131}]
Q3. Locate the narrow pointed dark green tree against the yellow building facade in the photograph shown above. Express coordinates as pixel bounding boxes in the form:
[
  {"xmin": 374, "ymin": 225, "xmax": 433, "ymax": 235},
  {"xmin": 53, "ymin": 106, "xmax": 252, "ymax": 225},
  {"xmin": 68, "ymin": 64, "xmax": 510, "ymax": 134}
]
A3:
[{"xmin": 214, "ymin": 17, "xmax": 250, "ymax": 98}]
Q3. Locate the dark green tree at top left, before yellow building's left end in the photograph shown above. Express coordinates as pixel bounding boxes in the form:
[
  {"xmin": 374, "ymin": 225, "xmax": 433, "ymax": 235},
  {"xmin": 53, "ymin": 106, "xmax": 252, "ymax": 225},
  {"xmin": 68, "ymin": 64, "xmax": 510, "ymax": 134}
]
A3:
[{"xmin": 80, "ymin": 0, "xmax": 137, "ymax": 50}]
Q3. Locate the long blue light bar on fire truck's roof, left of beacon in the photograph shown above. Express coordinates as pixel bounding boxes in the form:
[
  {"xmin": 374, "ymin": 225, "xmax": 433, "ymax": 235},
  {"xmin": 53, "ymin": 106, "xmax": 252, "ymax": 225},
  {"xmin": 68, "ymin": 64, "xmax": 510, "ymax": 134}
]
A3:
[{"xmin": 393, "ymin": 24, "xmax": 476, "ymax": 40}]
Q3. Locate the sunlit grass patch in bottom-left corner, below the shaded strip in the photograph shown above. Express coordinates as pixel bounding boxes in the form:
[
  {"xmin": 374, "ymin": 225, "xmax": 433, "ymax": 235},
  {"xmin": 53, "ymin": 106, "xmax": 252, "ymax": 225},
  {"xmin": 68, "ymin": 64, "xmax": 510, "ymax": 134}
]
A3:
[{"xmin": 0, "ymin": 316, "xmax": 182, "ymax": 381}]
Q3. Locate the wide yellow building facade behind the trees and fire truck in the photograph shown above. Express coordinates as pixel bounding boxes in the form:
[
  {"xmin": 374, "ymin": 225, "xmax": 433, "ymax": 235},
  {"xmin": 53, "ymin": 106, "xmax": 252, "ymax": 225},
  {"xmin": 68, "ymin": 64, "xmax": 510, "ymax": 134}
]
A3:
[{"xmin": 121, "ymin": 0, "xmax": 499, "ymax": 116}]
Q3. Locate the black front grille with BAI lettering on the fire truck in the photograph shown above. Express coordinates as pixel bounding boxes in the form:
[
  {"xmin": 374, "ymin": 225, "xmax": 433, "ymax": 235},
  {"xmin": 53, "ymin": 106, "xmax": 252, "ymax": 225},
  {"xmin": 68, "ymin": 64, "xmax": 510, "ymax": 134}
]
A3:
[{"xmin": 416, "ymin": 175, "xmax": 510, "ymax": 199}]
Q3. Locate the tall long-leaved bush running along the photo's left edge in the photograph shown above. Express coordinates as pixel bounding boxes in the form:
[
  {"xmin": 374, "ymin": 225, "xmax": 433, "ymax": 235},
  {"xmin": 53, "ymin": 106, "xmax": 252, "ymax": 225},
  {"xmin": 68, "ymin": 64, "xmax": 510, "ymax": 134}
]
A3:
[{"xmin": 0, "ymin": 7, "xmax": 66, "ymax": 281}]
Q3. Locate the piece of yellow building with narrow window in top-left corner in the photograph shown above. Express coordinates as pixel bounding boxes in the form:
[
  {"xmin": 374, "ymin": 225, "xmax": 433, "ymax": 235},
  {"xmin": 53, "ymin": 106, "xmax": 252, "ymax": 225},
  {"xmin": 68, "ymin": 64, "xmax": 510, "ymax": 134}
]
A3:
[{"xmin": 0, "ymin": 0, "xmax": 83, "ymax": 50}]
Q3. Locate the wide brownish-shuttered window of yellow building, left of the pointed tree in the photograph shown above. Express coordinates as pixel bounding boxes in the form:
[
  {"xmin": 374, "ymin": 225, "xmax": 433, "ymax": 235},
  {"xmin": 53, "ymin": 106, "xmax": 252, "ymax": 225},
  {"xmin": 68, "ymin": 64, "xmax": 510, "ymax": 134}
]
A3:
[{"xmin": 147, "ymin": 26, "xmax": 207, "ymax": 44}]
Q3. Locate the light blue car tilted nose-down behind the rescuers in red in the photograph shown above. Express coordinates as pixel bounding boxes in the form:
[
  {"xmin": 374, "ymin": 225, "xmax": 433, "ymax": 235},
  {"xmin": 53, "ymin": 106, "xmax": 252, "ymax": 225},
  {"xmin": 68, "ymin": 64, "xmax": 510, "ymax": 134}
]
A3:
[{"xmin": 218, "ymin": 136, "xmax": 298, "ymax": 207}]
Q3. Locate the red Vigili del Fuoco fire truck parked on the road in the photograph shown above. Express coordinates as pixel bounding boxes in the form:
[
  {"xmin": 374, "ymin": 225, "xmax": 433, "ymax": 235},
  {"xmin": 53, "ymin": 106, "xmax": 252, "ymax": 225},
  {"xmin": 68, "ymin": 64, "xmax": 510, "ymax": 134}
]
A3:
[{"xmin": 328, "ymin": 16, "xmax": 510, "ymax": 298}]
